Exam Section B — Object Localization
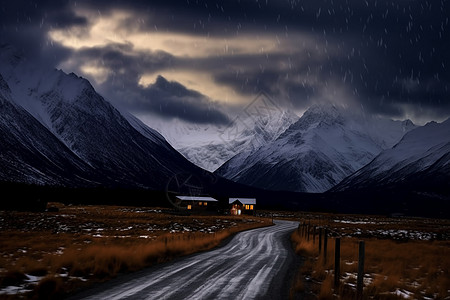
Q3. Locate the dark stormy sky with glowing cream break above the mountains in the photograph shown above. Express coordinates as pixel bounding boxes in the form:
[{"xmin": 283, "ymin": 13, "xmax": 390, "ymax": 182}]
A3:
[{"xmin": 0, "ymin": 0, "xmax": 450, "ymax": 124}]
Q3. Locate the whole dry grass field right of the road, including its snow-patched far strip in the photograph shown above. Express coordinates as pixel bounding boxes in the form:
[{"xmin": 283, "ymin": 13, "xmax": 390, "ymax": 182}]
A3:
[{"xmin": 291, "ymin": 214, "xmax": 450, "ymax": 299}]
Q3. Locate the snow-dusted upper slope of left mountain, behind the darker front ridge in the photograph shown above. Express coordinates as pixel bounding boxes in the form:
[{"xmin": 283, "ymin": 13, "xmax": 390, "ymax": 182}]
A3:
[{"xmin": 0, "ymin": 46, "xmax": 200, "ymax": 188}]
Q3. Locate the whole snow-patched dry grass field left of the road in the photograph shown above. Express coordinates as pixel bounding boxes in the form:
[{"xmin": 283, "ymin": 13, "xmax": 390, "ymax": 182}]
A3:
[{"xmin": 0, "ymin": 203, "xmax": 271, "ymax": 299}]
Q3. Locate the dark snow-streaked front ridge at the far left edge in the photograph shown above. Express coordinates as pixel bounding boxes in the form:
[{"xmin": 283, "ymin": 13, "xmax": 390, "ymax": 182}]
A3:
[{"xmin": 0, "ymin": 75, "xmax": 100, "ymax": 186}]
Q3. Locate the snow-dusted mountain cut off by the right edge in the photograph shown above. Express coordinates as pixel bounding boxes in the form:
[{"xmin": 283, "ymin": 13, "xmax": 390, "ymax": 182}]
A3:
[{"xmin": 331, "ymin": 119, "xmax": 450, "ymax": 192}]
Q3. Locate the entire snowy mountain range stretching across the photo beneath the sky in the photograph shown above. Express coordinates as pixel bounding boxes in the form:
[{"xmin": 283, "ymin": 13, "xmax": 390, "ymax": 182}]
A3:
[{"xmin": 0, "ymin": 46, "xmax": 450, "ymax": 213}]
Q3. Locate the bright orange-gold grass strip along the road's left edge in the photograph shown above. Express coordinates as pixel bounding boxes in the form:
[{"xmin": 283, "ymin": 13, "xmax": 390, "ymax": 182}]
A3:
[{"xmin": 46, "ymin": 230, "xmax": 237, "ymax": 278}]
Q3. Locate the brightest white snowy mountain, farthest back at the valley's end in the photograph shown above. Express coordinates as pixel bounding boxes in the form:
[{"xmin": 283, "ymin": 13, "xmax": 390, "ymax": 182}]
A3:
[{"xmin": 144, "ymin": 110, "xmax": 298, "ymax": 172}]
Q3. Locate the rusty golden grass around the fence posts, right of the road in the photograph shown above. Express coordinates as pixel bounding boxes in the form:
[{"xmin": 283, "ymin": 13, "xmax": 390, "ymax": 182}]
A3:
[{"xmin": 291, "ymin": 220, "xmax": 450, "ymax": 299}]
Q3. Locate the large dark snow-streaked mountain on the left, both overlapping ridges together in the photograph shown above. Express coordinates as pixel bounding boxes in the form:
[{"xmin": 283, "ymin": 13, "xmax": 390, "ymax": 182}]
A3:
[{"xmin": 0, "ymin": 46, "xmax": 202, "ymax": 188}]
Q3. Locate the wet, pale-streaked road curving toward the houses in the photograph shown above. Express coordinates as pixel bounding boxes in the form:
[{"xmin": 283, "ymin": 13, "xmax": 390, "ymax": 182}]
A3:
[{"xmin": 72, "ymin": 220, "xmax": 298, "ymax": 300}]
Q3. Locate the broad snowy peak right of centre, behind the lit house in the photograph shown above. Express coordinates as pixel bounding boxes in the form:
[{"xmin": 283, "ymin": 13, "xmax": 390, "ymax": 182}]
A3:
[{"xmin": 215, "ymin": 105, "xmax": 415, "ymax": 193}]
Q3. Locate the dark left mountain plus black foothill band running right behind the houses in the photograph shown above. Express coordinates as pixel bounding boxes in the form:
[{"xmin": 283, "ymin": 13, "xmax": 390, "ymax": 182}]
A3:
[{"xmin": 0, "ymin": 46, "xmax": 449, "ymax": 216}]
